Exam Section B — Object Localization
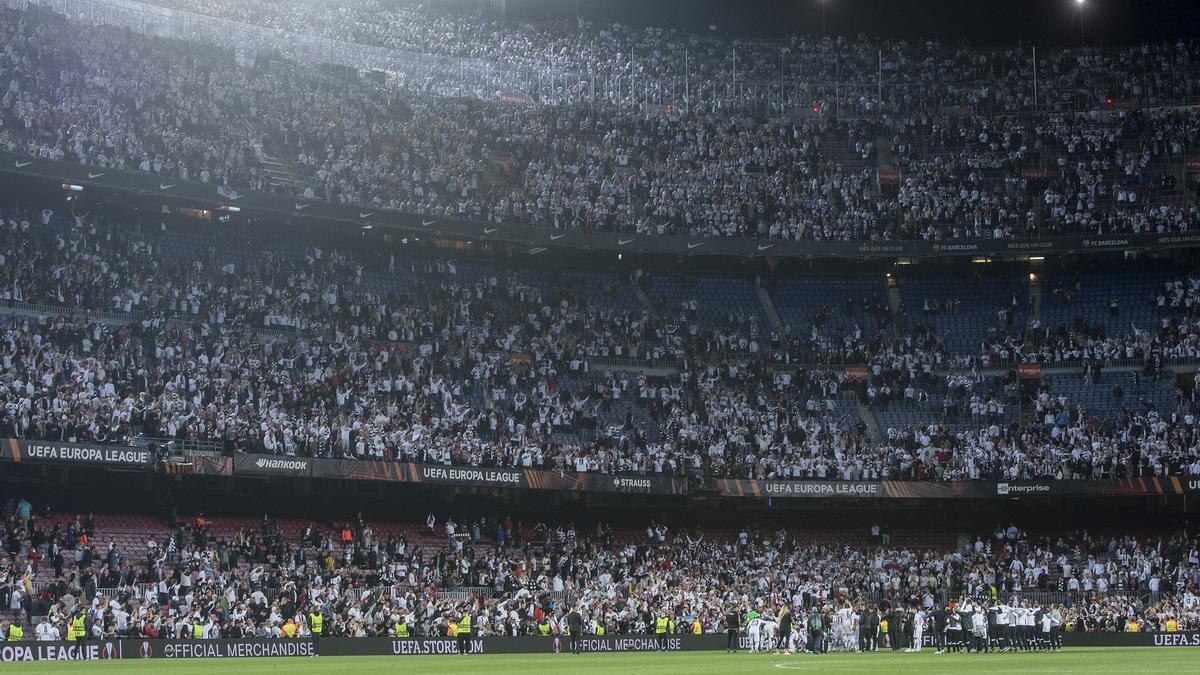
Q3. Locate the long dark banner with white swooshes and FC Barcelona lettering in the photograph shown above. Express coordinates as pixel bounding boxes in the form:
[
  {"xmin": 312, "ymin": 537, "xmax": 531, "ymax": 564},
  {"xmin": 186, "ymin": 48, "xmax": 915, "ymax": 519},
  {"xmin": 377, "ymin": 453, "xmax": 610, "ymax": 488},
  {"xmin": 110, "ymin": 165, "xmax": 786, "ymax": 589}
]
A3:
[{"xmin": 0, "ymin": 153, "xmax": 1200, "ymax": 258}]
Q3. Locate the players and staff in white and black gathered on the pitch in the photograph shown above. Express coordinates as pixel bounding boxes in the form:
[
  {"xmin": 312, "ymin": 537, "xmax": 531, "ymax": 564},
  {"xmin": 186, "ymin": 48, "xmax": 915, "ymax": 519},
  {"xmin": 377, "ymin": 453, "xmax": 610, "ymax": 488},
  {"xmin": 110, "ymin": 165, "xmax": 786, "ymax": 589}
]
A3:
[{"xmin": 726, "ymin": 598, "xmax": 1064, "ymax": 653}]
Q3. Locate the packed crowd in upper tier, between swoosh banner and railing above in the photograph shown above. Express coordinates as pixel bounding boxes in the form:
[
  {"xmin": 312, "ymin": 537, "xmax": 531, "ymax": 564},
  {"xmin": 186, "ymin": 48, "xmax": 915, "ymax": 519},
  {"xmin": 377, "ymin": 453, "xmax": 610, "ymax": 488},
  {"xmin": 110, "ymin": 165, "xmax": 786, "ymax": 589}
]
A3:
[{"xmin": 0, "ymin": 4, "xmax": 1200, "ymax": 240}]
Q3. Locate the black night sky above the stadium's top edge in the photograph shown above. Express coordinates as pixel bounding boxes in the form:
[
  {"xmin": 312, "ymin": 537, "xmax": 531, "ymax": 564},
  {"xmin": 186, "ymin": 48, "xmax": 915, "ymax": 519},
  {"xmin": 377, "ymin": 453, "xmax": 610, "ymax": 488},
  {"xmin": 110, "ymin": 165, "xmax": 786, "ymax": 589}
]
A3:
[{"xmin": 484, "ymin": 0, "xmax": 1200, "ymax": 46}]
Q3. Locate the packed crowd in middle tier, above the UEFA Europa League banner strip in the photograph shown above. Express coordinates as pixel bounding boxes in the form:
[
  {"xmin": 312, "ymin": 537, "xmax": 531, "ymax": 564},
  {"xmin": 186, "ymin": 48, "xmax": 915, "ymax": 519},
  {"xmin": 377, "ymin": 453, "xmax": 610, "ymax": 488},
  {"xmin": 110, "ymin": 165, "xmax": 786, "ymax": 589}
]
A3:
[{"xmin": 7, "ymin": 210, "xmax": 1200, "ymax": 480}]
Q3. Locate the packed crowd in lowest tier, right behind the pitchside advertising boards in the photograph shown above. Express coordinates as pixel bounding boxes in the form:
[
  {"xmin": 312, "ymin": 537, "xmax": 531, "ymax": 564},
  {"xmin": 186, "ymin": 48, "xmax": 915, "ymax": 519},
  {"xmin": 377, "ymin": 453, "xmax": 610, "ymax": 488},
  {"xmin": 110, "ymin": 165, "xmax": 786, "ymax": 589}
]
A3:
[{"xmin": 0, "ymin": 500, "xmax": 1200, "ymax": 639}]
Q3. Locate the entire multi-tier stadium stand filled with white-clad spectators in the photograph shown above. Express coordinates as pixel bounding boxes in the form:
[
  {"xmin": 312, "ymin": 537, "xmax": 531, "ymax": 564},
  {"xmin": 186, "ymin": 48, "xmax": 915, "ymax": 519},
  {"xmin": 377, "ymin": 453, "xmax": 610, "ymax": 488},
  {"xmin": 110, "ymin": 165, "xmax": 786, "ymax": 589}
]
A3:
[{"xmin": 0, "ymin": 0, "xmax": 1200, "ymax": 651}]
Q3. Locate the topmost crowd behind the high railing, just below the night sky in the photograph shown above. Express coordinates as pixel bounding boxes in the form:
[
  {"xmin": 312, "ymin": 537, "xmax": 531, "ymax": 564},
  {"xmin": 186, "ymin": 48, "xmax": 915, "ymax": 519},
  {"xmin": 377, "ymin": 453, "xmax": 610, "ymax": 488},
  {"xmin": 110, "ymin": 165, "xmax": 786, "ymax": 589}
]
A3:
[{"xmin": 126, "ymin": 0, "xmax": 1200, "ymax": 114}]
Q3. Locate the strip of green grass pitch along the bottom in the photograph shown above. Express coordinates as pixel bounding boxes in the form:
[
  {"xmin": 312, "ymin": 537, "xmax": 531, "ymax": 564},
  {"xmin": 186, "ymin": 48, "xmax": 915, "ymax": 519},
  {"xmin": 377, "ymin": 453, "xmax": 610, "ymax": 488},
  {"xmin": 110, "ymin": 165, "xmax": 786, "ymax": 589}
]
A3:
[{"xmin": 2, "ymin": 647, "xmax": 1200, "ymax": 675}]
